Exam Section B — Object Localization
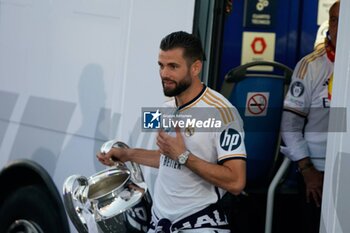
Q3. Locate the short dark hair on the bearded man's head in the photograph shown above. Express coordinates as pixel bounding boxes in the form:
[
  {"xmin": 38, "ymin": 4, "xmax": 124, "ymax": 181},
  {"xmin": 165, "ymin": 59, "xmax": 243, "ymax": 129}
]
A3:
[{"xmin": 160, "ymin": 31, "xmax": 204, "ymax": 64}]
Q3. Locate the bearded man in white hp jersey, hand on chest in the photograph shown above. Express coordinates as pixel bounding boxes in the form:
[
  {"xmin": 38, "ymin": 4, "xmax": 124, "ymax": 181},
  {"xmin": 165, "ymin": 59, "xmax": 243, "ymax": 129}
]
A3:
[{"xmin": 97, "ymin": 31, "xmax": 246, "ymax": 233}]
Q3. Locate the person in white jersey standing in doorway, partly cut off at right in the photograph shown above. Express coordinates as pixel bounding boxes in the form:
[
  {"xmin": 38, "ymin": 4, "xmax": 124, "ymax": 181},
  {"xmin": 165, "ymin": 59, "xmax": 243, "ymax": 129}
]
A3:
[{"xmin": 281, "ymin": 1, "xmax": 340, "ymax": 233}]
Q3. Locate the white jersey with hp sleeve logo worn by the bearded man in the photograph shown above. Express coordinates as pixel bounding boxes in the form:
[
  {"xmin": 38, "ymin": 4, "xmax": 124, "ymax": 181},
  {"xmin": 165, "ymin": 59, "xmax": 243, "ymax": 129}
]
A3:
[{"xmin": 153, "ymin": 87, "xmax": 246, "ymax": 222}]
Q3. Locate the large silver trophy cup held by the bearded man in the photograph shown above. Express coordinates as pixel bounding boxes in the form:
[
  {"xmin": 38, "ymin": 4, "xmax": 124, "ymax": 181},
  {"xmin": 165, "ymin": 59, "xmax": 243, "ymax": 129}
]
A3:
[{"xmin": 63, "ymin": 140, "xmax": 151, "ymax": 233}]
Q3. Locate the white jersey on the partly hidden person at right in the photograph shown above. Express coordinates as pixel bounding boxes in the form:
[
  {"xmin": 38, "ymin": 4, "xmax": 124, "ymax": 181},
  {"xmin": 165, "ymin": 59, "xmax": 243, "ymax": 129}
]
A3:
[{"xmin": 281, "ymin": 48, "xmax": 334, "ymax": 171}]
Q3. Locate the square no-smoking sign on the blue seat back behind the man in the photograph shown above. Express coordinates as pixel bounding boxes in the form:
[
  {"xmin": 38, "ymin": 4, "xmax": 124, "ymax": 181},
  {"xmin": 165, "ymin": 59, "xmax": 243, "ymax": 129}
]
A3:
[{"xmin": 244, "ymin": 92, "xmax": 270, "ymax": 116}]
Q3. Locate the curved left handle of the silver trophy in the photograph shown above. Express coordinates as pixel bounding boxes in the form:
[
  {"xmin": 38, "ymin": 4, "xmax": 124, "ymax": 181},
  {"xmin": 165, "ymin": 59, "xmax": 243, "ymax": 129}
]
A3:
[{"xmin": 63, "ymin": 175, "xmax": 91, "ymax": 233}]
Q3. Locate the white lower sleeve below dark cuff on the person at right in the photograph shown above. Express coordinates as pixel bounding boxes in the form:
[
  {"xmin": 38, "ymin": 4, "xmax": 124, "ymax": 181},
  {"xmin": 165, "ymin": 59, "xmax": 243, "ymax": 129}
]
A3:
[{"xmin": 281, "ymin": 111, "xmax": 309, "ymax": 161}]
